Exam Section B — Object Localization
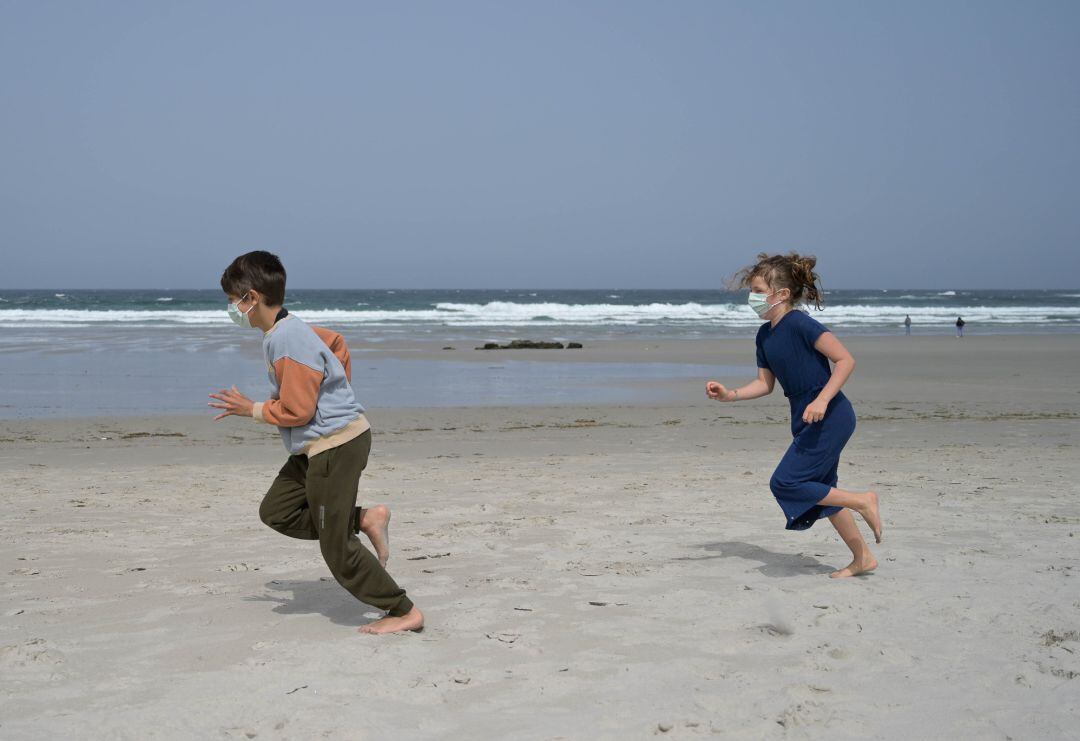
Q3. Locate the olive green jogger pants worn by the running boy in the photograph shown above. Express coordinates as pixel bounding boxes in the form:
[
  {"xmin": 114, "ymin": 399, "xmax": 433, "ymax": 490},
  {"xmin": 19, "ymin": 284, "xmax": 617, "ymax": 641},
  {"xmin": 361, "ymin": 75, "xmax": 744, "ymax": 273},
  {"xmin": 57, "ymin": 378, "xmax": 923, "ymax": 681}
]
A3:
[{"xmin": 259, "ymin": 430, "xmax": 413, "ymax": 616}]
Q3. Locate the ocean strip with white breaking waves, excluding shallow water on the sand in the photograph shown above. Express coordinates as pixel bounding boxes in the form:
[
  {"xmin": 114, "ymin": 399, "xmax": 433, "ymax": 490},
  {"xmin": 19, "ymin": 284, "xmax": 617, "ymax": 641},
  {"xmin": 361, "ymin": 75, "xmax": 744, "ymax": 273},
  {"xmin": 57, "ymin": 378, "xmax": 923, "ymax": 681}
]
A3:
[{"xmin": 0, "ymin": 289, "xmax": 1080, "ymax": 339}]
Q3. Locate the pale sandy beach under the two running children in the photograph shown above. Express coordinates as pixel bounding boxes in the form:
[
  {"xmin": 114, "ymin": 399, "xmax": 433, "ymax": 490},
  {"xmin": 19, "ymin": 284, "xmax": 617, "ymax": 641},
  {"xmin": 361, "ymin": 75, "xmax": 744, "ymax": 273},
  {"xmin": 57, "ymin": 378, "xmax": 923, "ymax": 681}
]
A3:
[{"xmin": 0, "ymin": 335, "xmax": 1080, "ymax": 740}]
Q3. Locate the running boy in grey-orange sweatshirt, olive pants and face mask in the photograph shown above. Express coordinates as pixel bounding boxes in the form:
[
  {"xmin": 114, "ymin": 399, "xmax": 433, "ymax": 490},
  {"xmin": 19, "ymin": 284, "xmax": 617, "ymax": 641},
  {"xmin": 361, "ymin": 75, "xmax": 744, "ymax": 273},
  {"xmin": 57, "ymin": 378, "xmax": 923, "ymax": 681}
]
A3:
[{"xmin": 210, "ymin": 252, "xmax": 423, "ymax": 633}]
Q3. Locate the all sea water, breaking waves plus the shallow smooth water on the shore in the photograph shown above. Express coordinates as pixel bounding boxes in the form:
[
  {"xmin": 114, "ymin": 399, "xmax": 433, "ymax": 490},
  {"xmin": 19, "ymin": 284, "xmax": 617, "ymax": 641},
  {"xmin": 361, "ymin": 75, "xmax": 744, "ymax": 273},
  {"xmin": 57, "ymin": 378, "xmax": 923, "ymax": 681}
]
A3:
[{"xmin": 0, "ymin": 289, "xmax": 1080, "ymax": 418}]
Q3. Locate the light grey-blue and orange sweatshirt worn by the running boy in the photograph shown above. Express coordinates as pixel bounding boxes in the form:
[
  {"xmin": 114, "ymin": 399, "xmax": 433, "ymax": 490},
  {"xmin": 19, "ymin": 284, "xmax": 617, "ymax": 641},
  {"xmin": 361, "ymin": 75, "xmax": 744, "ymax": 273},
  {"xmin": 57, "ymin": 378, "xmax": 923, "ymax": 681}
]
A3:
[{"xmin": 252, "ymin": 311, "xmax": 370, "ymax": 457}]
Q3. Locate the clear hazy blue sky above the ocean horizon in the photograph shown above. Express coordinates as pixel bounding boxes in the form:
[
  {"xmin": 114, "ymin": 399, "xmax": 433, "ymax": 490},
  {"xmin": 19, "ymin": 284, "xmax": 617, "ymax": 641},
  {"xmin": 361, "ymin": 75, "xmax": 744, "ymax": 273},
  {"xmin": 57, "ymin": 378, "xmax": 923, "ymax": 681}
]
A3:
[{"xmin": 0, "ymin": 0, "xmax": 1080, "ymax": 288}]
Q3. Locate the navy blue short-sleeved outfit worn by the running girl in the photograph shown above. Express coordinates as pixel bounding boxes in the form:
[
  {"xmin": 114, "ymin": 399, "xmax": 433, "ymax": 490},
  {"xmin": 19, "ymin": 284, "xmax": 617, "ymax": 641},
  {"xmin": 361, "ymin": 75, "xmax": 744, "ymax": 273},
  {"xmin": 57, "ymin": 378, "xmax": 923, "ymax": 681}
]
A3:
[{"xmin": 757, "ymin": 311, "xmax": 855, "ymax": 530}]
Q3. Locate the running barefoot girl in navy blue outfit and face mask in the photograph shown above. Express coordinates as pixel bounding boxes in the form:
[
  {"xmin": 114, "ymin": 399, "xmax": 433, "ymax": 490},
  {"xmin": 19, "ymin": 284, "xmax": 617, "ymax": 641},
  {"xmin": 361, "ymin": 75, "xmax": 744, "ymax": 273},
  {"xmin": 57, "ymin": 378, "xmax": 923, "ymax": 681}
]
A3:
[{"xmin": 705, "ymin": 253, "xmax": 881, "ymax": 579}]
